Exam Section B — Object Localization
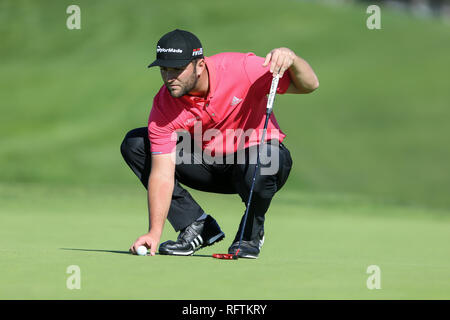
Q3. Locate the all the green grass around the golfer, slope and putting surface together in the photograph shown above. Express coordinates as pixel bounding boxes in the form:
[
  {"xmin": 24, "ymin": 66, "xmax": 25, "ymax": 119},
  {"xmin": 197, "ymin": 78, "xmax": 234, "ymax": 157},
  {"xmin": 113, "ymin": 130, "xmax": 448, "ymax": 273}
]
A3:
[{"xmin": 0, "ymin": 0, "xmax": 450, "ymax": 299}]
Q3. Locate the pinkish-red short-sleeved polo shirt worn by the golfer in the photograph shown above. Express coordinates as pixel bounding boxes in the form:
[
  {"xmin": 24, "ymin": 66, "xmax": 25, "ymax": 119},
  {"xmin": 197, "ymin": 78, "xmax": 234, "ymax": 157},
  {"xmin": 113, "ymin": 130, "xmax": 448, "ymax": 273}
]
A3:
[{"xmin": 148, "ymin": 52, "xmax": 291, "ymax": 155}]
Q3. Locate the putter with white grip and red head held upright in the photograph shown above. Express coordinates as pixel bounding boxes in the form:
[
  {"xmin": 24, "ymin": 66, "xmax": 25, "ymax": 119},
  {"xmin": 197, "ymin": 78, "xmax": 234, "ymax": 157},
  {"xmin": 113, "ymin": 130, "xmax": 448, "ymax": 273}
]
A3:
[{"xmin": 212, "ymin": 74, "xmax": 280, "ymax": 260}]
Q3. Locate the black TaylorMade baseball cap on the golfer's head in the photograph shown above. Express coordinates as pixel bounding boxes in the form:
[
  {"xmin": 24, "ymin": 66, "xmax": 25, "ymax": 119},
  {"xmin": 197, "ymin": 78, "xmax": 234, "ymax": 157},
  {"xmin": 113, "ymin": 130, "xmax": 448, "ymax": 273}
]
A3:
[{"xmin": 148, "ymin": 29, "xmax": 203, "ymax": 68}]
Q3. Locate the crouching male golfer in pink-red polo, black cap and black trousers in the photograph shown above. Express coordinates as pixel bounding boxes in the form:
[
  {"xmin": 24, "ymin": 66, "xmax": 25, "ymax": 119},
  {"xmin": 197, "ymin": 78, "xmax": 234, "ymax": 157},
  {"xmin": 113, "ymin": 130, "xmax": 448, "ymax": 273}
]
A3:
[{"xmin": 121, "ymin": 29, "xmax": 319, "ymax": 258}]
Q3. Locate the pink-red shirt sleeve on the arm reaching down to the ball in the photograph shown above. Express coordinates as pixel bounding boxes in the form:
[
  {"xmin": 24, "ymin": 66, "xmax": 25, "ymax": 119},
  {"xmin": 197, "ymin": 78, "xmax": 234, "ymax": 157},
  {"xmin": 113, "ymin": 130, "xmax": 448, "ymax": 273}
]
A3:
[{"xmin": 148, "ymin": 97, "xmax": 177, "ymax": 154}]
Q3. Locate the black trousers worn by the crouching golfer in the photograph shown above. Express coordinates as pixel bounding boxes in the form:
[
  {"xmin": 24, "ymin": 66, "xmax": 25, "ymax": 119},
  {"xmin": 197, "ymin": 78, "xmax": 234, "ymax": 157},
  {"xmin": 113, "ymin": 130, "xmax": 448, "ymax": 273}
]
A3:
[{"xmin": 120, "ymin": 127, "xmax": 292, "ymax": 240}]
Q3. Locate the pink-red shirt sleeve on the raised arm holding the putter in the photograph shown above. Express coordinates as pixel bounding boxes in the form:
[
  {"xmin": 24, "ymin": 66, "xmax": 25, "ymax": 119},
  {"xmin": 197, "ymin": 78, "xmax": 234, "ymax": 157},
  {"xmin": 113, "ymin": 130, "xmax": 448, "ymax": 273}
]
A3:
[{"xmin": 244, "ymin": 52, "xmax": 291, "ymax": 94}]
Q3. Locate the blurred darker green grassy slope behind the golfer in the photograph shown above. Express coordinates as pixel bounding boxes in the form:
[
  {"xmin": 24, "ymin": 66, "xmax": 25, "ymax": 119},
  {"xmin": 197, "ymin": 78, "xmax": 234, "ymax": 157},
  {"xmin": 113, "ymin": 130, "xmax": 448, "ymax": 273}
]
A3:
[{"xmin": 0, "ymin": 0, "xmax": 450, "ymax": 208}]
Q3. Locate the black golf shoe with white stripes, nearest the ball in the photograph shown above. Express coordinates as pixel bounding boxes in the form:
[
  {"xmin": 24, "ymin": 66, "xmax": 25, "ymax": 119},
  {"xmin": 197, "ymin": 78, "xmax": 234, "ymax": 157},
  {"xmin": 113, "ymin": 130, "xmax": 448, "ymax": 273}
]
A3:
[{"xmin": 159, "ymin": 215, "xmax": 225, "ymax": 256}]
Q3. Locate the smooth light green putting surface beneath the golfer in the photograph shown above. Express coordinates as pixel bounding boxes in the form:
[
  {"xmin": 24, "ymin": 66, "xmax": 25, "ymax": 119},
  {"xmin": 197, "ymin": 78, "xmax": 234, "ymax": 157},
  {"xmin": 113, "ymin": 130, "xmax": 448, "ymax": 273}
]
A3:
[{"xmin": 0, "ymin": 184, "xmax": 450, "ymax": 299}]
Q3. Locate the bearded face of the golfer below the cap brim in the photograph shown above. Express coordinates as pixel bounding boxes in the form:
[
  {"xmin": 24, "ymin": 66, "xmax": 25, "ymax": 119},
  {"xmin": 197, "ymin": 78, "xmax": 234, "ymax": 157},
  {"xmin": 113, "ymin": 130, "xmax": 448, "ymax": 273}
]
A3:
[{"xmin": 160, "ymin": 61, "xmax": 198, "ymax": 98}]
